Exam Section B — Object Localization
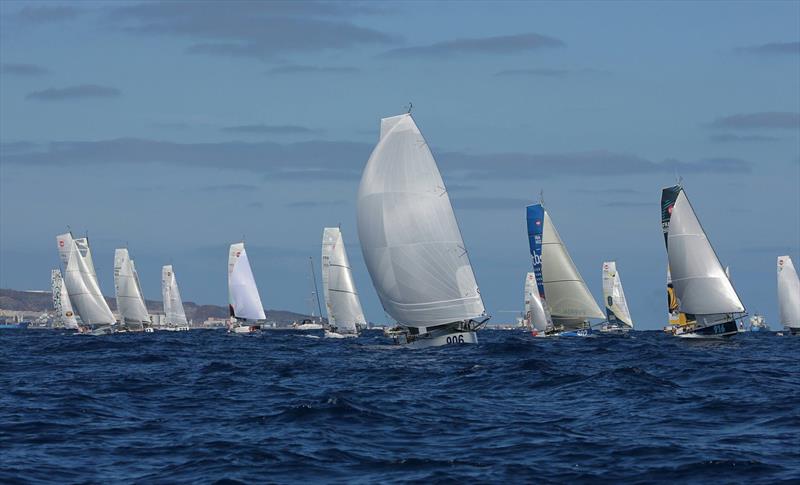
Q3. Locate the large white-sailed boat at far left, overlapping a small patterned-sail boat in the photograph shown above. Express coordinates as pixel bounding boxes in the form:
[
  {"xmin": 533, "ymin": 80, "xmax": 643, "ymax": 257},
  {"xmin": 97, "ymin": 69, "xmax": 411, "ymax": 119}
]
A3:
[{"xmin": 56, "ymin": 232, "xmax": 116, "ymax": 335}]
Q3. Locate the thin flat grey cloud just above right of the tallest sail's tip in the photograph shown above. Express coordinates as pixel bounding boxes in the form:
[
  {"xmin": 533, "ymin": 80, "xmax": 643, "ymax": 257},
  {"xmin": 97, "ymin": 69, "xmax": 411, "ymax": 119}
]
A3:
[{"xmin": 380, "ymin": 33, "xmax": 566, "ymax": 59}]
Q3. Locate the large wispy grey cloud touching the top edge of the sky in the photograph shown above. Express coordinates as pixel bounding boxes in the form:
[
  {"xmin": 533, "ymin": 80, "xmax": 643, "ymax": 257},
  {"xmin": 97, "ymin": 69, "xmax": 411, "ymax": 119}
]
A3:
[{"xmin": 105, "ymin": 1, "xmax": 398, "ymax": 59}]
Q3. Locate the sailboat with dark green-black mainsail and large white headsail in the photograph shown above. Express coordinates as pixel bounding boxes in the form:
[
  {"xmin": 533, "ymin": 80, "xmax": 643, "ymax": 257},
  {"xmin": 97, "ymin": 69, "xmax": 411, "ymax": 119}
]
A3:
[{"xmin": 661, "ymin": 185, "xmax": 745, "ymax": 338}]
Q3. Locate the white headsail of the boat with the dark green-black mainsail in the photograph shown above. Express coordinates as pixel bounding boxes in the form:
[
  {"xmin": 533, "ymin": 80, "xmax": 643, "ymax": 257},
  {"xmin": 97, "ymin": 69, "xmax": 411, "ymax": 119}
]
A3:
[{"xmin": 667, "ymin": 190, "xmax": 744, "ymax": 315}]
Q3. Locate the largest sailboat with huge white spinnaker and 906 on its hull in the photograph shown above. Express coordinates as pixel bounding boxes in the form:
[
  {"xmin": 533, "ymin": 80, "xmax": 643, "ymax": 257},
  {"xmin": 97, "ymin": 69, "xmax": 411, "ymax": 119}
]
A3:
[{"xmin": 358, "ymin": 113, "xmax": 489, "ymax": 348}]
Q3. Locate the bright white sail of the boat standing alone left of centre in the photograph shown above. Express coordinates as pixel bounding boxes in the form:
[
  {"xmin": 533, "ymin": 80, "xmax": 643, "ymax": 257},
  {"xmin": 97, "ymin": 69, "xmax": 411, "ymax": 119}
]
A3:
[{"xmin": 228, "ymin": 243, "xmax": 267, "ymax": 320}]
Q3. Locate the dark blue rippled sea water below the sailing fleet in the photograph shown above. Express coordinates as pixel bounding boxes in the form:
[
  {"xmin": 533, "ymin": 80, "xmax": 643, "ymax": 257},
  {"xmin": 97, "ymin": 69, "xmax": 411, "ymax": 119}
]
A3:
[{"xmin": 0, "ymin": 330, "xmax": 800, "ymax": 483}]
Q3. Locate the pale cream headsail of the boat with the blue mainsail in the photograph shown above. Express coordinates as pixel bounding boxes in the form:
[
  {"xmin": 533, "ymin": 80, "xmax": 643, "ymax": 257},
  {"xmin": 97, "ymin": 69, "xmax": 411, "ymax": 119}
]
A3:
[{"xmin": 542, "ymin": 211, "xmax": 605, "ymax": 320}]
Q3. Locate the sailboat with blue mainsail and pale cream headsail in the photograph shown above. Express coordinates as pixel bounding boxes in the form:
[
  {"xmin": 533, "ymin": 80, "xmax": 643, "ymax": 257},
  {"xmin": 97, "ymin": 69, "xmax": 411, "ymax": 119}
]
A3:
[{"xmin": 527, "ymin": 203, "xmax": 605, "ymax": 337}]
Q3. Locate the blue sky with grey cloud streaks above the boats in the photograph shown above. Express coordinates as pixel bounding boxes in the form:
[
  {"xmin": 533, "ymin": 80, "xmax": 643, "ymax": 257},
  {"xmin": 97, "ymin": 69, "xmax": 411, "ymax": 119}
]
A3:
[{"xmin": 0, "ymin": 1, "xmax": 800, "ymax": 329}]
